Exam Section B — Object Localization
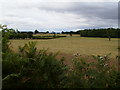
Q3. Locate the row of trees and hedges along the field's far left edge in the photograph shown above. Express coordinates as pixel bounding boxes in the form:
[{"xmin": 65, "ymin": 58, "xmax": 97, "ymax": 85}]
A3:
[{"xmin": 2, "ymin": 26, "xmax": 66, "ymax": 39}]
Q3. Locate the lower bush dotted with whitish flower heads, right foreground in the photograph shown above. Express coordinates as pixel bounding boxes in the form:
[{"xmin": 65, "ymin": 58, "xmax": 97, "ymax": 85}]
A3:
[{"xmin": 65, "ymin": 55, "xmax": 120, "ymax": 88}]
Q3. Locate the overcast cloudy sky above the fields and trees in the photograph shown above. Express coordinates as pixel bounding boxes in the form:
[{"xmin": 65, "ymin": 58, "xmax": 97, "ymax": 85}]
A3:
[{"xmin": 0, "ymin": 0, "xmax": 118, "ymax": 32}]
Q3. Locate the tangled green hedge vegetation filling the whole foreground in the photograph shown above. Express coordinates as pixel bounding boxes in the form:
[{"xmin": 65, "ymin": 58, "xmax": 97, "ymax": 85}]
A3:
[{"xmin": 2, "ymin": 25, "xmax": 120, "ymax": 88}]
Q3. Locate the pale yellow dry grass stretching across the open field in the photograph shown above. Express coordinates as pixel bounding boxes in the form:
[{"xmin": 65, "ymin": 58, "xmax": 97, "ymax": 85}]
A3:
[{"xmin": 10, "ymin": 35, "xmax": 118, "ymax": 57}]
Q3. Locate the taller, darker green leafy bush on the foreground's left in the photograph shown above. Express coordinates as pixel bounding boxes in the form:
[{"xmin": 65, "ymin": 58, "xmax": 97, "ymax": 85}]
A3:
[{"xmin": 3, "ymin": 42, "xmax": 67, "ymax": 88}]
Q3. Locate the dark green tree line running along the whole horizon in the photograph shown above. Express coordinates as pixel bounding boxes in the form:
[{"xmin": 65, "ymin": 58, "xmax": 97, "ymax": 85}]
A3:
[{"xmin": 2, "ymin": 26, "xmax": 120, "ymax": 40}]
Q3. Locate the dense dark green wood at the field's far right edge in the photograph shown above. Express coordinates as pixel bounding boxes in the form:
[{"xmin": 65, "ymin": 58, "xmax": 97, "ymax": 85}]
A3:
[{"xmin": 80, "ymin": 28, "xmax": 120, "ymax": 38}]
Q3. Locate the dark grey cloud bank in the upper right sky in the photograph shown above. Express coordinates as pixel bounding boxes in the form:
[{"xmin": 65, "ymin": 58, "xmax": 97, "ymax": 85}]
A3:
[{"xmin": 37, "ymin": 2, "xmax": 118, "ymax": 19}]
